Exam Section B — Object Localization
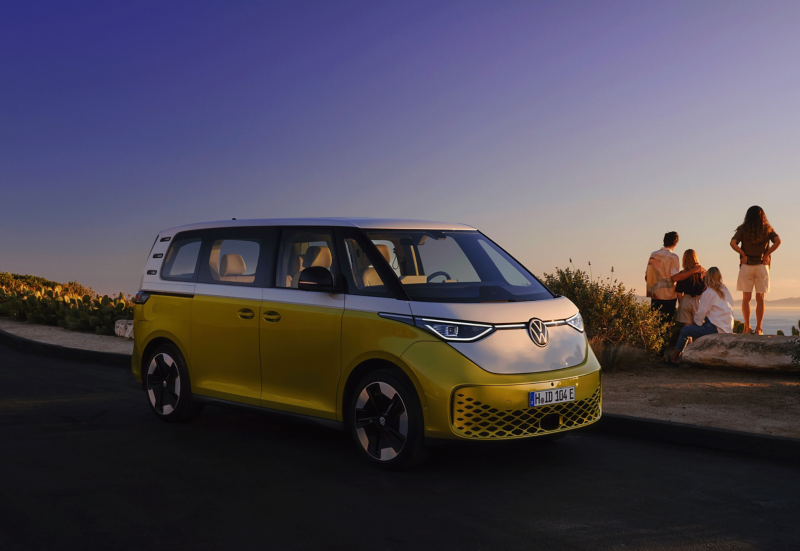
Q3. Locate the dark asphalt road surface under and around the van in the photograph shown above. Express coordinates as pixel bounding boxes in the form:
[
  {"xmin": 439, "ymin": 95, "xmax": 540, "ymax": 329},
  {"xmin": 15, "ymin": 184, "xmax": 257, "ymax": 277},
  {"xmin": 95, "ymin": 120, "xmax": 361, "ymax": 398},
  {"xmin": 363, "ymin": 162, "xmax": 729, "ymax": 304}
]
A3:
[{"xmin": 0, "ymin": 347, "xmax": 800, "ymax": 551}]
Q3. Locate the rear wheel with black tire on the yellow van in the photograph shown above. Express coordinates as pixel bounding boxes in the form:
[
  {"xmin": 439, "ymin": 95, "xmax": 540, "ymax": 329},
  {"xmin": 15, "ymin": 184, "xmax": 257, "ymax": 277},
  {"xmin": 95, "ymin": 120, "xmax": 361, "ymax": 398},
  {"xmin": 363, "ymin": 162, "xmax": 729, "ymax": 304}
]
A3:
[{"xmin": 142, "ymin": 344, "xmax": 203, "ymax": 423}]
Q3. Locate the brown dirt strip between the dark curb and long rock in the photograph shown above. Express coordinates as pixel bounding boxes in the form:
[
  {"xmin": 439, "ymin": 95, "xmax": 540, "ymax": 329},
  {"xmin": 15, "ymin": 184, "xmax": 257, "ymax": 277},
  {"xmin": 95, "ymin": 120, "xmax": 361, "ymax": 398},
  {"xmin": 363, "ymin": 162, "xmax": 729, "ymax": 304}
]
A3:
[{"xmin": 603, "ymin": 357, "xmax": 800, "ymax": 438}]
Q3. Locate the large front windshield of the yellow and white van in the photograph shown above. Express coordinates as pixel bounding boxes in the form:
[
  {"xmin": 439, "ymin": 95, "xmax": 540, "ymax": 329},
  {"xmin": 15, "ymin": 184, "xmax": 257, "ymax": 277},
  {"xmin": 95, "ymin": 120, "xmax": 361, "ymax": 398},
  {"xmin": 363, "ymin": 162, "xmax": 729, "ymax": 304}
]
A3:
[{"xmin": 366, "ymin": 230, "xmax": 553, "ymax": 302}]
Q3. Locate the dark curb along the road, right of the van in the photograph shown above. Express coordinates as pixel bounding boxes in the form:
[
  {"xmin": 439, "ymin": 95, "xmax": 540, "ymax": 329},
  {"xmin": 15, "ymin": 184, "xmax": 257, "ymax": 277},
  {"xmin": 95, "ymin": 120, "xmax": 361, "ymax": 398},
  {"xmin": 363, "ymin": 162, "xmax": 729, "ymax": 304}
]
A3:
[{"xmin": 594, "ymin": 413, "xmax": 800, "ymax": 462}]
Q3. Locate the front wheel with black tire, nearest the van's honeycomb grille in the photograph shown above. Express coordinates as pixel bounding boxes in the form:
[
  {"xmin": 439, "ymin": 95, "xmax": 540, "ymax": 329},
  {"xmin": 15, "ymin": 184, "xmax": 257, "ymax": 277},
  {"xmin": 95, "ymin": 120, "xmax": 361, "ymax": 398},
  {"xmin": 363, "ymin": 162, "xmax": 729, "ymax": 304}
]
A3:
[{"xmin": 347, "ymin": 369, "xmax": 428, "ymax": 470}]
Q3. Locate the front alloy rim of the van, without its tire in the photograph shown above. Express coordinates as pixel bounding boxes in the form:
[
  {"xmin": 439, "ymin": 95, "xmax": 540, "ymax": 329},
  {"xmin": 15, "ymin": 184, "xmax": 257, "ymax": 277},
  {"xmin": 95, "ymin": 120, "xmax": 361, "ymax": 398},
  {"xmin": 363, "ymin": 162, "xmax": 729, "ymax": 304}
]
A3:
[{"xmin": 355, "ymin": 382, "xmax": 408, "ymax": 461}]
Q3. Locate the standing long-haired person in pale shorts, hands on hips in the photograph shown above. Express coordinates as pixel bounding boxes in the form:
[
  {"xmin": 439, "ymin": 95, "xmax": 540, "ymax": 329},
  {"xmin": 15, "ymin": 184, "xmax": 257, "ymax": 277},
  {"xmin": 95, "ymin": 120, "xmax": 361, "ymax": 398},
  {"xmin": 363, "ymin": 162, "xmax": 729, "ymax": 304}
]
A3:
[{"xmin": 731, "ymin": 206, "xmax": 781, "ymax": 335}]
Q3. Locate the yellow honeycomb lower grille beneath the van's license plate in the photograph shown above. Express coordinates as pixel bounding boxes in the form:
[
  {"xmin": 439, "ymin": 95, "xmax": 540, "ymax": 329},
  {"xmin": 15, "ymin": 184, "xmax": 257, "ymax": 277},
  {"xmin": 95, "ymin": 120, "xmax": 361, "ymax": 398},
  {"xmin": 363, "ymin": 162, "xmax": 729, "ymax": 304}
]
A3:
[{"xmin": 453, "ymin": 387, "xmax": 601, "ymax": 439}]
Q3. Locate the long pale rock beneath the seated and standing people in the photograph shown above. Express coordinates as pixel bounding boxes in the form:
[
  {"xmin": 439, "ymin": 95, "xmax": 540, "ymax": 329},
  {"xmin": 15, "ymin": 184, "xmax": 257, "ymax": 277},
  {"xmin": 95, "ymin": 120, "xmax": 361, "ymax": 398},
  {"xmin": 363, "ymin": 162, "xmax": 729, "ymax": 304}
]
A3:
[{"xmin": 681, "ymin": 333, "xmax": 800, "ymax": 372}]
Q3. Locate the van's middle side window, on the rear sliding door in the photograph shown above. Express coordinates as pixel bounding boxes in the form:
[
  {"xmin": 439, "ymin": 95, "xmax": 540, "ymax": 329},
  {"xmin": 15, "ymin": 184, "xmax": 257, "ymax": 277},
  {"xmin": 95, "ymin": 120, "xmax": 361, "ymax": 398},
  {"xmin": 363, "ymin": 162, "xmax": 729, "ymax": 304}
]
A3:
[{"xmin": 200, "ymin": 230, "xmax": 265, "ymax": 285}]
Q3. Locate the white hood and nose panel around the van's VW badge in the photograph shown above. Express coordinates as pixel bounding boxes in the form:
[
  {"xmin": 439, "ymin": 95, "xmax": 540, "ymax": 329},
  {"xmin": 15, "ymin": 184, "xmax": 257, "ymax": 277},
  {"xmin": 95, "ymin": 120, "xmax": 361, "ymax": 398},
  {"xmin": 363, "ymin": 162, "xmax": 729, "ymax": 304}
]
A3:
[{"xmin": 410, "ymin": 297, "xmax": 588, "ymax": 375}]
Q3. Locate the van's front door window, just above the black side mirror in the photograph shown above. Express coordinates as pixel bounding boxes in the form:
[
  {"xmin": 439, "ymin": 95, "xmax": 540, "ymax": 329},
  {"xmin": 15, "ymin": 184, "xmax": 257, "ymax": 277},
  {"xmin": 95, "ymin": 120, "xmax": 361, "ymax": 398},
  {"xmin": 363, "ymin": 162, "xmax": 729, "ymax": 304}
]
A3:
[{"xmin": 275, "ymin": 229, "xmax": 336, "ymax": 289}]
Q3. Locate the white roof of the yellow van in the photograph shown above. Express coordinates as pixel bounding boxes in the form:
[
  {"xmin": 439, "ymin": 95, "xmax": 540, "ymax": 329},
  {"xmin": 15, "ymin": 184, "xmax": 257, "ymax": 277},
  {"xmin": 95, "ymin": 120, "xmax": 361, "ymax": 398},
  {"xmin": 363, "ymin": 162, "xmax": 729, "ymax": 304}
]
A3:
[{"xmin": 159, "ymin": 218, "xmax": 475, "ymax": 235}]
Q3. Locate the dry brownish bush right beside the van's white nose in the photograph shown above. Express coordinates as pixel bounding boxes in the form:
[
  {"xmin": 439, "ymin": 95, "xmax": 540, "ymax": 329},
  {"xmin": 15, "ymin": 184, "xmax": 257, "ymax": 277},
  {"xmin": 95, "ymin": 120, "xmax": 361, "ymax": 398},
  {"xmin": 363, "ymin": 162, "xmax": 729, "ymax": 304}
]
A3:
[{"xmin": 543, "ymin": 268, "xmax": 669, "ymax": 352}]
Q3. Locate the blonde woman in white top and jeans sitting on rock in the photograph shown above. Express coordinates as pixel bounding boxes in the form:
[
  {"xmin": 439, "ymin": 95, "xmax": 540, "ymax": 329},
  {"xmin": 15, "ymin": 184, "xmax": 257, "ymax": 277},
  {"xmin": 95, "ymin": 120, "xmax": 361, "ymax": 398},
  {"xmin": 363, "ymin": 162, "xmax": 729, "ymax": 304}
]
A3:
[{"xmin": 666, "ymin": 266, "xmax": 733, "ymax": 365}]
